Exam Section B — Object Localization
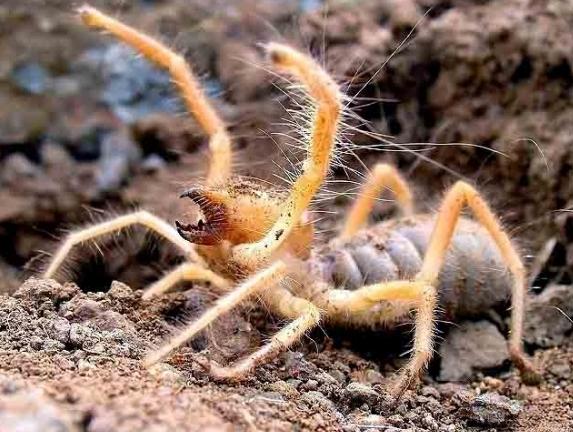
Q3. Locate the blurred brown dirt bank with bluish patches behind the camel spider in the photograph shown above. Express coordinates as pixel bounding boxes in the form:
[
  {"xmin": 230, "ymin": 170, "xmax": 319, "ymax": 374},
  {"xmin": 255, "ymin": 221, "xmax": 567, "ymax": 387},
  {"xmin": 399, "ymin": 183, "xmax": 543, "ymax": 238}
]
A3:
[{"xmin": 0, "ymin": 0, "xmax": 573, "ymax": 291}]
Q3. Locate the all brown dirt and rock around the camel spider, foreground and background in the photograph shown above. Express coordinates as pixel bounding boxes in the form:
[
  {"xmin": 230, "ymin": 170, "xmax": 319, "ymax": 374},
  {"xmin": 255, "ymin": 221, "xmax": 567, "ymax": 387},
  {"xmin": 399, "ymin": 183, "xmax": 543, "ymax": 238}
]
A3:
[{"xmin": 0, "ymin": 0, "xmax": 573, "ymax": 432}]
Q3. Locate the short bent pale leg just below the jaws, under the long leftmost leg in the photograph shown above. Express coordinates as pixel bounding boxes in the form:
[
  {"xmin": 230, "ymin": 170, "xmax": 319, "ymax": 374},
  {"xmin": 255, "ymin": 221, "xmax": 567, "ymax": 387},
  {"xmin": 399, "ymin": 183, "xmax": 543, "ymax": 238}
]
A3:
[{"xmin": 142, "ymin": 263, "xmax": 231, "ymax": 300}]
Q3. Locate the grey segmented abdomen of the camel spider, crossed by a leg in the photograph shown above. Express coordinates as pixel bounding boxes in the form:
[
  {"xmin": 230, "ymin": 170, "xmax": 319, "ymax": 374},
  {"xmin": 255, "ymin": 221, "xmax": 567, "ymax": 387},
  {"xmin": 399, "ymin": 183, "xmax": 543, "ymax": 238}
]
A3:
[{"xmin": 311, "ymin": 215, "xmax": 511, "ymax": 318}]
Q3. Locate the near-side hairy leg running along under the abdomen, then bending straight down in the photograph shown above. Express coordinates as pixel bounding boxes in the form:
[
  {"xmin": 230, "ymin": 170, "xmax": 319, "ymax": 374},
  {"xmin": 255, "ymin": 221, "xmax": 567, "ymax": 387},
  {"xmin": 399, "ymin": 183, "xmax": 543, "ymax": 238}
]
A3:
[{"xmin": 328, "ymin": 281, "xmax": 437, "ymax": 397}]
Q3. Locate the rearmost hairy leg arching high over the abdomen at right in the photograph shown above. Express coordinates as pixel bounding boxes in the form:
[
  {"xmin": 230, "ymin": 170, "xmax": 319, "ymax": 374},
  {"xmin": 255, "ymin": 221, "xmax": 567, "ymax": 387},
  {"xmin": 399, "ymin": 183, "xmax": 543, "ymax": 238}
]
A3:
[{"xmin": 418, "ymin": 181, "xmax": 539, "ymax": 382}]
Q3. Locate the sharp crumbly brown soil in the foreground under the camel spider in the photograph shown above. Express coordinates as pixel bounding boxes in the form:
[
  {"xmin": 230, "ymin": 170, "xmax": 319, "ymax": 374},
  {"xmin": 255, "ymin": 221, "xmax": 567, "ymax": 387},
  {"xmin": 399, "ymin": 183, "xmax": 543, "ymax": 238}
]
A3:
[{"xmin": 0, "ymin": 278, "xmax": 573, "ymax": 431}]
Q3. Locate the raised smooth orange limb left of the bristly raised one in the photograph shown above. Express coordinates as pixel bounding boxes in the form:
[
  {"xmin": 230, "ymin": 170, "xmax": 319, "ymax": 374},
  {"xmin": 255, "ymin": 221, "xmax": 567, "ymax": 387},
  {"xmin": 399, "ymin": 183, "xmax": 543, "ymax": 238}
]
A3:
[{"xmin": 78, "ymin": 6, "xmax": 232, "ymax": 184}]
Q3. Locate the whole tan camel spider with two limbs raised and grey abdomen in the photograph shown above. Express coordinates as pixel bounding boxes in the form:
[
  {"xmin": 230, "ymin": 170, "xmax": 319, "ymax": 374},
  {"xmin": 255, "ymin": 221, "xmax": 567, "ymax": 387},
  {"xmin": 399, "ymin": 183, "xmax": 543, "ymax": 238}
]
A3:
[{"xmin": 45, "ymin": 6, "xmax": 535, "ymax": 395}]
